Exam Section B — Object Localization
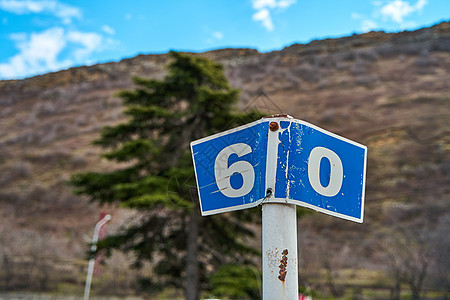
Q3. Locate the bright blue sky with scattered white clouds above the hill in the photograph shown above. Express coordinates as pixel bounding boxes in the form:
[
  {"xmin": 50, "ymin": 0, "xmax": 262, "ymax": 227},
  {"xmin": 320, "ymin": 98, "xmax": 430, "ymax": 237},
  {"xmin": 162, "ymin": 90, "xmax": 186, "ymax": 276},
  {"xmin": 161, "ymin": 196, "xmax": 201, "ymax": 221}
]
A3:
[{"xmin": 0, "ymin": 0, "xmax": 450, "ymax": 80}]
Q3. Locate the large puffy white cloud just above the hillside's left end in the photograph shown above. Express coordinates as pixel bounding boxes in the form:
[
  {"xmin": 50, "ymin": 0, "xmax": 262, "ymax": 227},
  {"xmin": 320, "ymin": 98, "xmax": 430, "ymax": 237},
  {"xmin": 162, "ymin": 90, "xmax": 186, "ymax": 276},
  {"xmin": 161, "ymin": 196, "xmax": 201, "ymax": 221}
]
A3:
[{"xmin": 0, "ymin": 27, "xmax": 103, "ymax": 79}]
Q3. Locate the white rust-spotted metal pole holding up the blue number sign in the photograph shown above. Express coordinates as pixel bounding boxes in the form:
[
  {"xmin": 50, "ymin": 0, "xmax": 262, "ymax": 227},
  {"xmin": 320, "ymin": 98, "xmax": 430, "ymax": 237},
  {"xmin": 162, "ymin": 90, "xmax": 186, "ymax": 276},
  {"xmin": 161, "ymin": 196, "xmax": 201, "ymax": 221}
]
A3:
[{"xmin": 262, "ymin": 116, "xmax": 298, "ymax": 300}]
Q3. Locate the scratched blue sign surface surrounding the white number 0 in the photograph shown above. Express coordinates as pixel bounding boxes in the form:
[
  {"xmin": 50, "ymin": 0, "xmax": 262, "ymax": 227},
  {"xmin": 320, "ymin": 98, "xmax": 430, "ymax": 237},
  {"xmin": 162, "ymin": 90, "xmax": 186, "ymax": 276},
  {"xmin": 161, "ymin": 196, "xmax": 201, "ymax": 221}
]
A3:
[{"xmin": 275, "ymin": 121, "xmax": 365, "ymax": 219}]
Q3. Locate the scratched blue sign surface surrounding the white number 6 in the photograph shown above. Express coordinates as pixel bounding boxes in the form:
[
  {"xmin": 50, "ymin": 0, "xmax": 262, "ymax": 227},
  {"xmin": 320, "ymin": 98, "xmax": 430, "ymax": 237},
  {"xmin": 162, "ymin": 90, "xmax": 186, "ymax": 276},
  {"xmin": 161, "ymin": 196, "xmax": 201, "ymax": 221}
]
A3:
[{"xmin": 192, "ymin": 122, "xmax": 268, "ymax": 213}]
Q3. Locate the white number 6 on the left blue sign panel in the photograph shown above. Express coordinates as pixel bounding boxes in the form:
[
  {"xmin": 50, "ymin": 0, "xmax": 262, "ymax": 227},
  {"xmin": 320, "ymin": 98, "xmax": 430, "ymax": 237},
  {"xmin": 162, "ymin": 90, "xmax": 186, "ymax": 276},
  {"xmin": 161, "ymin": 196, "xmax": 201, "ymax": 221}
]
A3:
[{"xmin": 214, "ymin": 143, "xmax": 255, "ymax": 198}]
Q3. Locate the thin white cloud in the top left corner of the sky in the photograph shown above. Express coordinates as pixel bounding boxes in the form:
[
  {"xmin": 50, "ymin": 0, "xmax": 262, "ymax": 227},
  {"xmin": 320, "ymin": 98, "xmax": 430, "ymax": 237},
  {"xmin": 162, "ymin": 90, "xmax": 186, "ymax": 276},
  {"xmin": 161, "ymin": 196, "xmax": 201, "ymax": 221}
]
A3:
[{"xmin": 0, "ymin": 0, "xmax": 82, "ymax": 24}]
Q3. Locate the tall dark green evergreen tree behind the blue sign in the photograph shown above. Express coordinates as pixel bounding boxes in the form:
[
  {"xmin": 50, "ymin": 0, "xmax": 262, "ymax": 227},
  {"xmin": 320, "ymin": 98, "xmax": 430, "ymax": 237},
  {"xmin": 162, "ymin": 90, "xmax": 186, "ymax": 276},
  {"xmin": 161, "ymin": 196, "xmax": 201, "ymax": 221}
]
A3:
[{"xmin": 70, "ymin": 52, "xmax": 261, "ymax": 300}]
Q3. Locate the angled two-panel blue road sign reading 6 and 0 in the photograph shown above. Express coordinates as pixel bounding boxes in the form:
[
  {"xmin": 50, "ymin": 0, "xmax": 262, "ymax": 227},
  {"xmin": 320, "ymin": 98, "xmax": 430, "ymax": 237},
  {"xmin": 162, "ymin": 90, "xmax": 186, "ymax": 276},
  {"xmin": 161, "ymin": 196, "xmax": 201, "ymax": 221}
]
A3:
[{"xmin": 191, "ymin": 118, "xmax": 367, "ymax": 222}]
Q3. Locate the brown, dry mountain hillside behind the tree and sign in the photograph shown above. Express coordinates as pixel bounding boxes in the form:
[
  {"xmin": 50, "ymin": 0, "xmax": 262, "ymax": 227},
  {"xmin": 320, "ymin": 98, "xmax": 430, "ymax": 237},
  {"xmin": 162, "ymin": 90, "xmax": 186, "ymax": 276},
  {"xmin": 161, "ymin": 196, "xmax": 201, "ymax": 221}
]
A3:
[{"xmin": 0, "ymin": 22, "xmax": 450, "ymax": 293}]
